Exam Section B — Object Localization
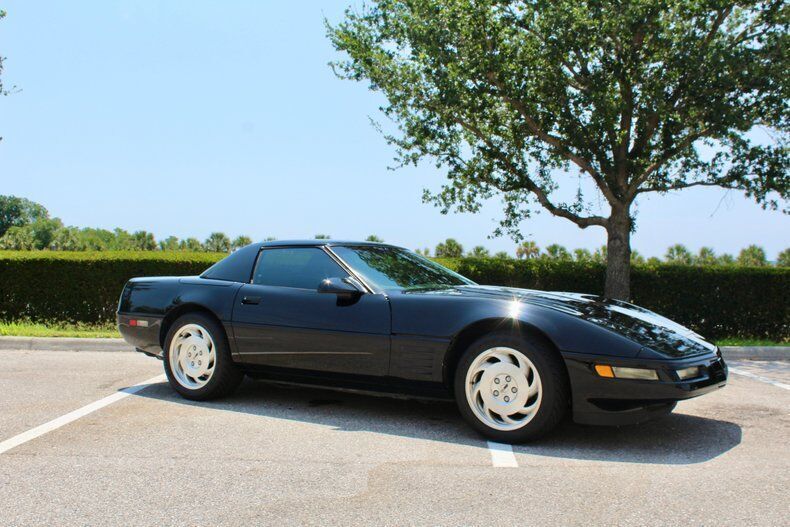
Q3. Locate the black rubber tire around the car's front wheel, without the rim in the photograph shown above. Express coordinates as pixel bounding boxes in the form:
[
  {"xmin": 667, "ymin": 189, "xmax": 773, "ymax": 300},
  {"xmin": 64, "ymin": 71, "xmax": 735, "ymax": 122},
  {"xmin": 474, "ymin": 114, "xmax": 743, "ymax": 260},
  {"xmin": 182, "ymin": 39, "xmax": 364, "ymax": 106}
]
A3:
[{"xmin": 454, "ymin": 333, "xmax": 570, "ymax": 443}]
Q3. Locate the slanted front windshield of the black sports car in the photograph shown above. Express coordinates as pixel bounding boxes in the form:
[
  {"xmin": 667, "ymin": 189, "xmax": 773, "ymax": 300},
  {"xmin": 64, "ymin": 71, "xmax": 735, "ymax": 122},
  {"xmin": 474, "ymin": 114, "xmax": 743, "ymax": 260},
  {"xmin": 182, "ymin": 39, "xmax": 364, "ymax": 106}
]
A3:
[{"xmin": 332, "ymin": 246, "xmax": 474, "ymax": 290}]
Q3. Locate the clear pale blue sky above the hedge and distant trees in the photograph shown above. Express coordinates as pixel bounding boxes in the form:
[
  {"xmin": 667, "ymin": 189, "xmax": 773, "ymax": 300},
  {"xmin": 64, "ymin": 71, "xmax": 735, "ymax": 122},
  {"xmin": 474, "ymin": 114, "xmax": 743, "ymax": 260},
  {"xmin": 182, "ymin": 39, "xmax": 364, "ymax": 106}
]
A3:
[{"xmin": 0, "ymin": 0, "xmax": 790, "ymax": 259}]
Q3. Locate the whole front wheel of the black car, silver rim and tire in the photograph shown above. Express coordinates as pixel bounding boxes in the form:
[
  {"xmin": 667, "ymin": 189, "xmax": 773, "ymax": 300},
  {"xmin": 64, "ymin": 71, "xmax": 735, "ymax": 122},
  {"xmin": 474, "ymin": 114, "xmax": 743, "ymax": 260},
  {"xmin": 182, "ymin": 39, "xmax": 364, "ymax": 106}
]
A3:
[{"xmin": 454, "ymin": 334, "xmax": 570, "ymax": 443}]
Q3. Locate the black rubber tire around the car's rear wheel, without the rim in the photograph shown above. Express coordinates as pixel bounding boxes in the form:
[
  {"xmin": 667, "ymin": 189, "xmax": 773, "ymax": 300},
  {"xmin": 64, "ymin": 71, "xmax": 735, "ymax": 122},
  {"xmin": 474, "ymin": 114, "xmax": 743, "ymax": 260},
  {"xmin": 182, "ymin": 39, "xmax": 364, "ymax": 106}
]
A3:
[{"xmin": 163, "ymin": 313, "xmax": 244, "ymax": 401}]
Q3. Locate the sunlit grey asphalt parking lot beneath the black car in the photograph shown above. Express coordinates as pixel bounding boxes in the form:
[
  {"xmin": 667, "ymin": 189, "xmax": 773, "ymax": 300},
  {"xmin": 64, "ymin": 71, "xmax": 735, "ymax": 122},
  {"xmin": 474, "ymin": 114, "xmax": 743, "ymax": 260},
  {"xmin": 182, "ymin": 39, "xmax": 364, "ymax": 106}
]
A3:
[{"xmin": 0, "ymin": 351, "xmax": 790, "ymax": 526}]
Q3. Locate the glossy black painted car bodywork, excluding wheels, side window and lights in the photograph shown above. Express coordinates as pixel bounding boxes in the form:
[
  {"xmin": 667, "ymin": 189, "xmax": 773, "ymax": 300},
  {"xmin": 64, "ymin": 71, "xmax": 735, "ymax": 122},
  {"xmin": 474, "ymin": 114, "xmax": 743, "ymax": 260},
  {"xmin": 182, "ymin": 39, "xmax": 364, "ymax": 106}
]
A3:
[{"xmin": 118, "ymin": 240, "xmax": 727, "ymax": 424}]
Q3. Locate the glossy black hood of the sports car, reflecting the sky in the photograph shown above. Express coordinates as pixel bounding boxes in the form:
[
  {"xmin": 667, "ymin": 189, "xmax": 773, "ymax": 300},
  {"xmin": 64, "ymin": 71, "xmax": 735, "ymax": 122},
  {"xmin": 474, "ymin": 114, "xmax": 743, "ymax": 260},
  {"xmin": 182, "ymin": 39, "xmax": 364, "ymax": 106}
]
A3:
[{"xmin": 408, "ymin": 285, "xmax": 716, "ymax": 358}]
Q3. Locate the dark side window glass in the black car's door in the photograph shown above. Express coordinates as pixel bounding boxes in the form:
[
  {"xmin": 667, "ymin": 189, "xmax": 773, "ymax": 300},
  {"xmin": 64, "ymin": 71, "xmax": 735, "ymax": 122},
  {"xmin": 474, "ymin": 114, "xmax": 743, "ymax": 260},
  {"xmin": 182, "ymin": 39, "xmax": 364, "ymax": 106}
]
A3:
[{"xmin": 252, "ymin": 247, "xmax": 348, "ymax": 290}]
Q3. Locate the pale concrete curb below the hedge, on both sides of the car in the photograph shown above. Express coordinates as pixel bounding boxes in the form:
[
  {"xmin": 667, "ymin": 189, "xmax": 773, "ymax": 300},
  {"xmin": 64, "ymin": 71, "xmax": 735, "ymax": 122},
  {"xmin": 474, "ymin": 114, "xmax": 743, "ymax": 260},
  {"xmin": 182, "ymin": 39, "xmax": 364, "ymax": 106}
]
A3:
[{"xmin": 0, "ymin": 337, "xmax": 790, "ymax": 361}]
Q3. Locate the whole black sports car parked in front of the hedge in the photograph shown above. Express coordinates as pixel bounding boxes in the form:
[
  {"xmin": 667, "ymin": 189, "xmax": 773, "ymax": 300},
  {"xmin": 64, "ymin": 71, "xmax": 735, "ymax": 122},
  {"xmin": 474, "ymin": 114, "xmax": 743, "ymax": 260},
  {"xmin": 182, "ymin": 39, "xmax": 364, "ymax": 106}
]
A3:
[{"xmin": 118, "ymin": 240, "xmax": 727, "ymax": 442}]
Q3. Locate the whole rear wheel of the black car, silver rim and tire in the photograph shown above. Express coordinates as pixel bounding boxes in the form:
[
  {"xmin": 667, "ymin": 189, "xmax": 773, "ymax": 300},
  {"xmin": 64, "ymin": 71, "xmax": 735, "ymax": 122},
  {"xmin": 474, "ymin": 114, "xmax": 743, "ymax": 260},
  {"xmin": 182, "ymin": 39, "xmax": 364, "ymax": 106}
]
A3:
[{"xmin": 164, "ymin": 313, "xmax": 244, "ymax": 401}]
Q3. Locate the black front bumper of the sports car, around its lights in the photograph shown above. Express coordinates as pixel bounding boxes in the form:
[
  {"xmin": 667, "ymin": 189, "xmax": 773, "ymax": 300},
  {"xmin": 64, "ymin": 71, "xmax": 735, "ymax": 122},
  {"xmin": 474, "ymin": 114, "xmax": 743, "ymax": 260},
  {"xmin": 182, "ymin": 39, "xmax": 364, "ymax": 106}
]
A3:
[{"xmin": 563, "ymin": 352, "xmax": 728, "ymax": 426}]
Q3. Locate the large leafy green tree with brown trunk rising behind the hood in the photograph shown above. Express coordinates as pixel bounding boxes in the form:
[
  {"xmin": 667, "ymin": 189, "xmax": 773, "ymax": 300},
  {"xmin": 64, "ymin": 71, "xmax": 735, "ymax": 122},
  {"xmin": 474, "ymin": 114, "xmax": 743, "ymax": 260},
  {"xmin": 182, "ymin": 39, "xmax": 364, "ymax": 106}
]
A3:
[{"xmin": 327, "ymin": 0, "xmax": 790, "ymax": 299}]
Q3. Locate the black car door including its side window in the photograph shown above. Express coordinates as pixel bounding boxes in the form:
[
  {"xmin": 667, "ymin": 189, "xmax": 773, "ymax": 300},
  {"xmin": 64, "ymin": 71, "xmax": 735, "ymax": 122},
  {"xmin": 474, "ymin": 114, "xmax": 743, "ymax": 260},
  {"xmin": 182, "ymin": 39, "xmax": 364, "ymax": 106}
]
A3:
[{"xmin": 233, "ymin": 246, "xmax": 390, "ymax": 376}]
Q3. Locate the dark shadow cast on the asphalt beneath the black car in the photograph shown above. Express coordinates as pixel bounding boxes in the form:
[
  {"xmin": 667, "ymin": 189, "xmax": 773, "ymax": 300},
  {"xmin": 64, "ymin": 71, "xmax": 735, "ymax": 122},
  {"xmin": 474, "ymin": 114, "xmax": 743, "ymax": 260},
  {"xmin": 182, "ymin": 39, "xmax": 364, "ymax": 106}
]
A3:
[{"xmin": 130, "ymin": 379, "xmax": 742, "ymax": 465}]
